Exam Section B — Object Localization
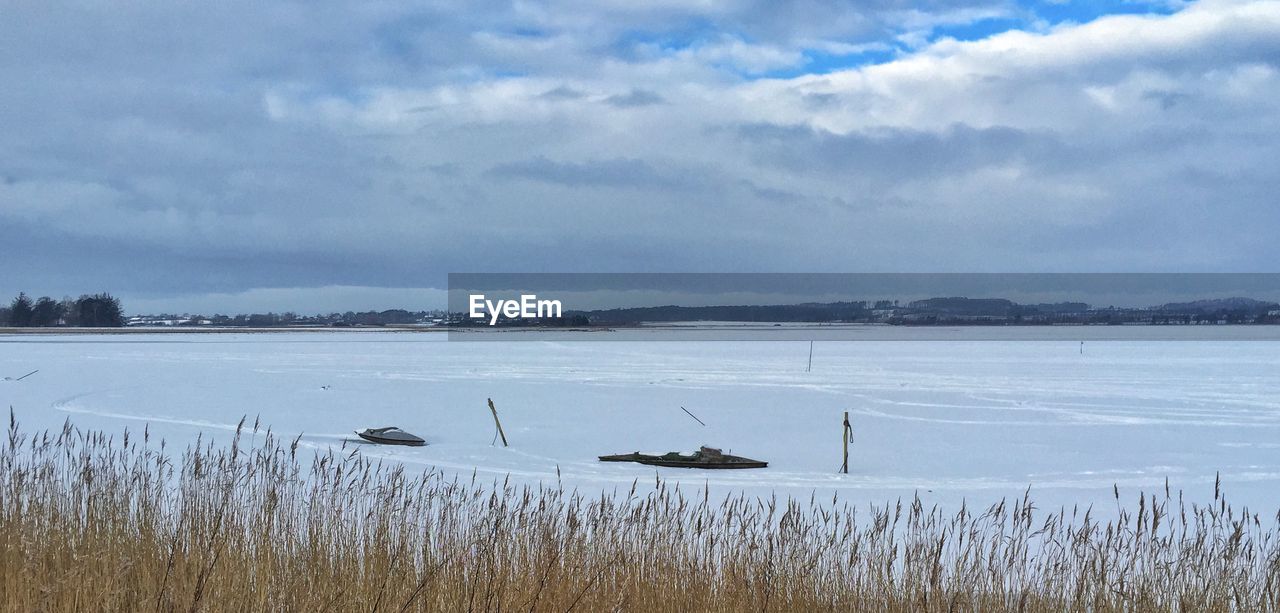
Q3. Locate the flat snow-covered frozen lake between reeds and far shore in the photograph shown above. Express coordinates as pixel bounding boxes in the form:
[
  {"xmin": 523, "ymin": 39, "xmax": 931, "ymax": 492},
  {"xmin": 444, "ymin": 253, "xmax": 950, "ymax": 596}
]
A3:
[{"xmin": 0, "ymin": 328, "xmax": 1280, "ymax": 514}]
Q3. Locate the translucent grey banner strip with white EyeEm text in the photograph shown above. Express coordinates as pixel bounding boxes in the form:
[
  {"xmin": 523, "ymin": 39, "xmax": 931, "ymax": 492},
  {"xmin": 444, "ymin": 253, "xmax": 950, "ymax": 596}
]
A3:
[{"xmin": 447, "ymin": 273, "xmax": 1280, "ymax": 340}]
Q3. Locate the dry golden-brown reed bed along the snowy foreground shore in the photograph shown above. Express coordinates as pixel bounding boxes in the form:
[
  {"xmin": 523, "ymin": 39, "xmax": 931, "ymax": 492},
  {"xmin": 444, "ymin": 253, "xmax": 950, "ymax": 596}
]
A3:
[{"xmin": 0, "ymin": 412, "xmax": 1280, "ymax": 612}]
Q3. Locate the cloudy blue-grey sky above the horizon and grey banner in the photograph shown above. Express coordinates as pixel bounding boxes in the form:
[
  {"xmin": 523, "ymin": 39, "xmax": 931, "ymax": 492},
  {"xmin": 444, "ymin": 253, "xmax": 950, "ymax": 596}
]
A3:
[{"xmin": 0, "ymin": 0, "xmax": 1280, "ymax": 312}]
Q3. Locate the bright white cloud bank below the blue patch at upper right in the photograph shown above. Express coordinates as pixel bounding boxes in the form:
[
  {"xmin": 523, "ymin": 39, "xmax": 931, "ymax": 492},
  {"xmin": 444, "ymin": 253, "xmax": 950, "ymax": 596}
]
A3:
[{"xmin": 742, "ymin": 3, "xmax": 1280, "ymax": 133}]
